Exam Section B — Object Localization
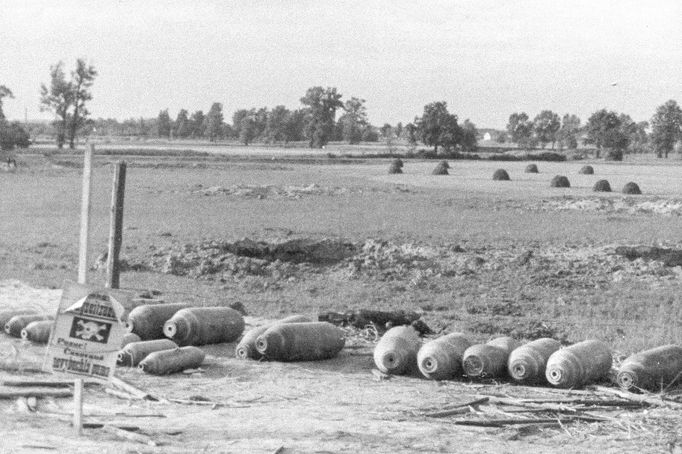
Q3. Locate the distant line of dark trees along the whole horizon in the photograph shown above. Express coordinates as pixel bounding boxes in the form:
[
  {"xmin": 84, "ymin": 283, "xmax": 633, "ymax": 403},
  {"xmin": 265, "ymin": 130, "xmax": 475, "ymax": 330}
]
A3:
[{"xmin": 0, "ymin": 58, "xmax": 682, "ymax": 159}]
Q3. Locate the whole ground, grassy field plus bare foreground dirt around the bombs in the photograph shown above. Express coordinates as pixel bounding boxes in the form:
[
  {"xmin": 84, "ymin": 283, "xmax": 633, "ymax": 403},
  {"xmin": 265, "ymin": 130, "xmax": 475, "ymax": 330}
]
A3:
[{"xmin": 0, "ymin": 153, "xmax": 682, "ymax": 453}]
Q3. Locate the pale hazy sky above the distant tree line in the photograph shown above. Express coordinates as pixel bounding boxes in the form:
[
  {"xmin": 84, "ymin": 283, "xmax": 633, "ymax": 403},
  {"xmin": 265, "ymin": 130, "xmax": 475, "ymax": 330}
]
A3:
[{"xmin": 0, "ymin": 0, "xmax": 682, "ymax": 128}]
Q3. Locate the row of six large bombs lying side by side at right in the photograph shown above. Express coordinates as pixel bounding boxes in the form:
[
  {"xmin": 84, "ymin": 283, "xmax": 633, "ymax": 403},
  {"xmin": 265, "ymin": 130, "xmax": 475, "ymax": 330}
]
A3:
[{"xmin": 374, "ymin": 326, "xmax": 682, "ymax": 390}]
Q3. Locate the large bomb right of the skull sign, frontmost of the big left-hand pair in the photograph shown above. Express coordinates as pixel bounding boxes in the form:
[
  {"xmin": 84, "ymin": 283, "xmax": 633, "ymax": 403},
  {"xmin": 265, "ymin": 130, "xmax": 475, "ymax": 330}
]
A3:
[{"xmin": 163, "ymin": 306, "xmax": 244, "ymax": 346}]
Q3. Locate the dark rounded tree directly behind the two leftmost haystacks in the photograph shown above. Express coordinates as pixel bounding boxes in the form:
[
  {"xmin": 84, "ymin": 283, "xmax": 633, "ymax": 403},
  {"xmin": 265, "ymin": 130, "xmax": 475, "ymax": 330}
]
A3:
[{"xmin": 415, "ymin": 101, "xmax": 462, "ymax": 153}]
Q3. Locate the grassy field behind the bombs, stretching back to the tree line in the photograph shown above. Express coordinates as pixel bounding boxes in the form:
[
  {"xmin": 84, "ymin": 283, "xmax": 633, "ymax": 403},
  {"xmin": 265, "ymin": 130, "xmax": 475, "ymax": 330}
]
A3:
[{"xmin": 0, "ymin": 153, "xmax": 682, "ymax": 452}]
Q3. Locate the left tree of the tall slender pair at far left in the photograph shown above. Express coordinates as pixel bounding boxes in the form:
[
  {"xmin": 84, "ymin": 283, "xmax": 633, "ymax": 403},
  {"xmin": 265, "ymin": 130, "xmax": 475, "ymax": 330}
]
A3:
[{"xmin": 40, "ymin": 61, "xmax": 74, "ymax": 149}]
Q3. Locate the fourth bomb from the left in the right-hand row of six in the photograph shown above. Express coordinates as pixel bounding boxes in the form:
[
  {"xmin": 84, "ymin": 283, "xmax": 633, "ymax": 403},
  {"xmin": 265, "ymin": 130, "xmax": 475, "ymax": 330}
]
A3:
[{"xmin": 507, "ymin": 337, "xmax": 561, "ymax": 383}]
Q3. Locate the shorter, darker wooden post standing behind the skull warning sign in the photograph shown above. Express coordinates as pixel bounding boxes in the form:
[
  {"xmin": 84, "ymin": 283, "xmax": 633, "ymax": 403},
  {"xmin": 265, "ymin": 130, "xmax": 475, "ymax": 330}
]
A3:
[{"xmin": 104, "ymin": 161, "xmax": 126, "ymax": 288}]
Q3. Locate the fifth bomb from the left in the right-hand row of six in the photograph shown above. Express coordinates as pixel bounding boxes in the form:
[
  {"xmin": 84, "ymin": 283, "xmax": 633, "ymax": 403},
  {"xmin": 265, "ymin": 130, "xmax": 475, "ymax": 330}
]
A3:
[{"xmin": 545, "ymin": 339, "xmax": 613, "ymax": 388}]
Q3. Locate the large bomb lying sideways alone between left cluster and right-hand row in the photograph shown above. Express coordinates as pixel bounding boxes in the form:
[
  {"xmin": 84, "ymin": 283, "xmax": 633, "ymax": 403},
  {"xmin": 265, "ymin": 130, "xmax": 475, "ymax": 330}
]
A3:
[{"xmin": 256, "ymin": 322, "xmax": 346, "ymax": 361}]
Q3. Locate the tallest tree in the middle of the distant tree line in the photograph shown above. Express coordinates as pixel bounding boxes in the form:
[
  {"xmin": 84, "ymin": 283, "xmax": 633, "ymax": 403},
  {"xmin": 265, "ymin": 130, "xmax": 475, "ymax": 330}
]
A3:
[{"xmin": 301, "ymin": 87, "xmax": 343, "ymax": 148}]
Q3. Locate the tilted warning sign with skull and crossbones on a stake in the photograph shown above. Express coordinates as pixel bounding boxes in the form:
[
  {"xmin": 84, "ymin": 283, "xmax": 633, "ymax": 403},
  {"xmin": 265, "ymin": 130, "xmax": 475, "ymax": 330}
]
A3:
[{"xmin": 43, "ymin": 282, "xmax": 127, "ymax": 381}]
